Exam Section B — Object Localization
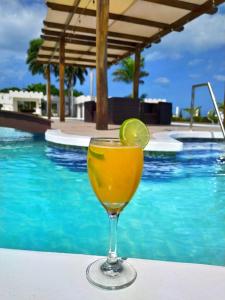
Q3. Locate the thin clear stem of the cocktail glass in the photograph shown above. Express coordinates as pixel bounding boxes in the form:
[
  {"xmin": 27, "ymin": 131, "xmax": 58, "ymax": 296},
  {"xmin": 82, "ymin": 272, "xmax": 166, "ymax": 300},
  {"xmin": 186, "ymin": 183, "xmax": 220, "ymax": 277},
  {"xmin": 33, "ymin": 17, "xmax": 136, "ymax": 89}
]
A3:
[{"xmin": 107, "ymin": 213, "xmax": 119, "ymax": 264}]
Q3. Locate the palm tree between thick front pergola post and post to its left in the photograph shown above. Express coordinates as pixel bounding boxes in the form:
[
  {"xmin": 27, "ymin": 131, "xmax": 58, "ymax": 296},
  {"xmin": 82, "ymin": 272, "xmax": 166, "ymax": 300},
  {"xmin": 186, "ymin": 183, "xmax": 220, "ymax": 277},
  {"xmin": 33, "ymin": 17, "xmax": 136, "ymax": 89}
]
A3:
[{"xmin": 65, "ymin": 66, "xmax": 88, "ymax": 115}]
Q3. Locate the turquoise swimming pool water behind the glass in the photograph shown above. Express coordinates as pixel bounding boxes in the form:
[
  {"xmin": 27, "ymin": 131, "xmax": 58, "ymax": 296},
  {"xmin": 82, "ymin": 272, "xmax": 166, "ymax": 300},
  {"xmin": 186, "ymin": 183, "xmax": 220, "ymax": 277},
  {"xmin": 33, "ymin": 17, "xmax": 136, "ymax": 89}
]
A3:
[{"xmin": 0, "ymin": 128, "xmax": 225, "ymax": 265}]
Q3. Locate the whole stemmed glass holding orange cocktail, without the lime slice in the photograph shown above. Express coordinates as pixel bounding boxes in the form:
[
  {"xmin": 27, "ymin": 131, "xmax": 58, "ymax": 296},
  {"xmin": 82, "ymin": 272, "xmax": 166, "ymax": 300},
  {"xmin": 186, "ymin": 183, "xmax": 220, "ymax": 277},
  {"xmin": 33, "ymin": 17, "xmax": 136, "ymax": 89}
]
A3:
[{"xmin": 86, "ymin": 138, "xmax": 143, "ymax": 290}]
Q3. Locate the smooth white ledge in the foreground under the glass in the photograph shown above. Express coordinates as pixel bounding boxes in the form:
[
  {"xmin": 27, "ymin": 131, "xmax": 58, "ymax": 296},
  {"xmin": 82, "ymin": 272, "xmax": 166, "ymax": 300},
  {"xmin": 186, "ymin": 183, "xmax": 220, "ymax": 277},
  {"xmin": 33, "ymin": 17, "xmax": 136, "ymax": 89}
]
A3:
[{"xmin": 0, "ymin": 249, "xmax": 225, "ymax": 300}]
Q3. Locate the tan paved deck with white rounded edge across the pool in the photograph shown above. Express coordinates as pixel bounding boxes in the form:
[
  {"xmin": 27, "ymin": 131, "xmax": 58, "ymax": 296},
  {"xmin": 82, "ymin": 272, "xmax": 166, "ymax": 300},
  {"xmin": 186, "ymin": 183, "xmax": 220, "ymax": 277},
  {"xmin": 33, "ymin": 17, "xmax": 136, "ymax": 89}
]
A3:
[{"xmin": 45, "ymin": 119, "xmax": 223, "ymax": 152}]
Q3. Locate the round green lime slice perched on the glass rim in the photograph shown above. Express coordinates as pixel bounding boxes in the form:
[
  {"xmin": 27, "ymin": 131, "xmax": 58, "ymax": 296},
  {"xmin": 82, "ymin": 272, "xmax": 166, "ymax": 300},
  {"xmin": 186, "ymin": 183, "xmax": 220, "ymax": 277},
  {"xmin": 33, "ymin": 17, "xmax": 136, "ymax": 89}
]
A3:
[{"xmin": 120, "ymin": 118, "xmax": 150, "ymax": 148}]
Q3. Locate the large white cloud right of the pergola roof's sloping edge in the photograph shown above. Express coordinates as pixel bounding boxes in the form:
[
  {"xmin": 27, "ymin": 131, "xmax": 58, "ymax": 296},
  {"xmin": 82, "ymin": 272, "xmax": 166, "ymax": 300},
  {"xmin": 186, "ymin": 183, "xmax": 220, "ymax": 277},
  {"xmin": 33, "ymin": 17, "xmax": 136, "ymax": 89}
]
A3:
[{"xmin": 146, "ymin": 8, "xmax": 225, "ymax": 61}]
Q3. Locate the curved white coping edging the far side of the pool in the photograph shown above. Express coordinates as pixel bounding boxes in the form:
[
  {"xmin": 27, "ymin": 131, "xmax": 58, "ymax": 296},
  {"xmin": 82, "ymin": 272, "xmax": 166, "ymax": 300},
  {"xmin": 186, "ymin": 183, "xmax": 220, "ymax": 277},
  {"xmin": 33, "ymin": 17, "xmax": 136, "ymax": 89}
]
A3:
[{"xmin": 45, "ymin": 129, "xmax": 223, "ymax": 152}]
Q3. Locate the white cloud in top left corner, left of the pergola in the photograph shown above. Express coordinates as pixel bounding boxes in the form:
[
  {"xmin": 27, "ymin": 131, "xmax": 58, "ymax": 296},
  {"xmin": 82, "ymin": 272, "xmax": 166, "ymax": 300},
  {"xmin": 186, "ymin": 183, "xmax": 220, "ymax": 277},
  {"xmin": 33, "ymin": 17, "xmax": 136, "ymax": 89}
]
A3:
[{"xmin": 0, "ymin": 0, "xmax": 45, "ymax": 64}]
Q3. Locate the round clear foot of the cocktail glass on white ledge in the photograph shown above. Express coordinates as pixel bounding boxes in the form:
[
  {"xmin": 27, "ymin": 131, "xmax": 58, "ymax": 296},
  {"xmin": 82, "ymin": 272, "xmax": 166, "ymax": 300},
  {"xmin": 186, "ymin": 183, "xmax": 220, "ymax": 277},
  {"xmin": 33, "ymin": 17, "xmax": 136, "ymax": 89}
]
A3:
[{"xmin": 86, "ymin": 258, "xmax": 137, "ymax": 290}]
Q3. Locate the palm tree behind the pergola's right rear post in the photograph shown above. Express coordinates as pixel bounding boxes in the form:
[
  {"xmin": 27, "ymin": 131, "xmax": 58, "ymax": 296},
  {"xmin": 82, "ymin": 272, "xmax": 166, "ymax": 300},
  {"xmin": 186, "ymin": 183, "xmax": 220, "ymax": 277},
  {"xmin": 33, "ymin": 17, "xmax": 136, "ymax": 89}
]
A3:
[{"xmin": 112, "ymin": 56, "xmax": 149, "ymax": 98}]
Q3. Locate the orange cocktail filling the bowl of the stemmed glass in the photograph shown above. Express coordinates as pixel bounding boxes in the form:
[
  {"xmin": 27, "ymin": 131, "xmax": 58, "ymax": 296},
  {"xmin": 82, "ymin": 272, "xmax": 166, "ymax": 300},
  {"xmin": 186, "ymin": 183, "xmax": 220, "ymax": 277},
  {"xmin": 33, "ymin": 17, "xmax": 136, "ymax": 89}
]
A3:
[{"xmin": 87, "ymin": 139, "xmax": 143, "ymax": 214}]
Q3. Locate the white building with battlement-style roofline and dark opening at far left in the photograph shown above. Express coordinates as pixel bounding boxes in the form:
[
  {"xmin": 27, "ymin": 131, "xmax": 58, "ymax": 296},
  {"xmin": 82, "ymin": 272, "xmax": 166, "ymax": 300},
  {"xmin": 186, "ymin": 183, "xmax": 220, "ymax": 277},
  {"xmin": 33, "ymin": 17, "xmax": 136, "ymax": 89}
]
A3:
[{"xmin": 0, "ymin": 91, "xmax": 44, "ymax": 115}]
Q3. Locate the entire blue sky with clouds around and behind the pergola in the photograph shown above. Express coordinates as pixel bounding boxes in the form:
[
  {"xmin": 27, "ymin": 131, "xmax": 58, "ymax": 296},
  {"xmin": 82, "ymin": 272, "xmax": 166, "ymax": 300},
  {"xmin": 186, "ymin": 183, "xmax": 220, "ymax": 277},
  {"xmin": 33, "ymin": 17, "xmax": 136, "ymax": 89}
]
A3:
[{"xmin": 0, "ymin": 0, "xmax": 225, "ymax": 115}]
